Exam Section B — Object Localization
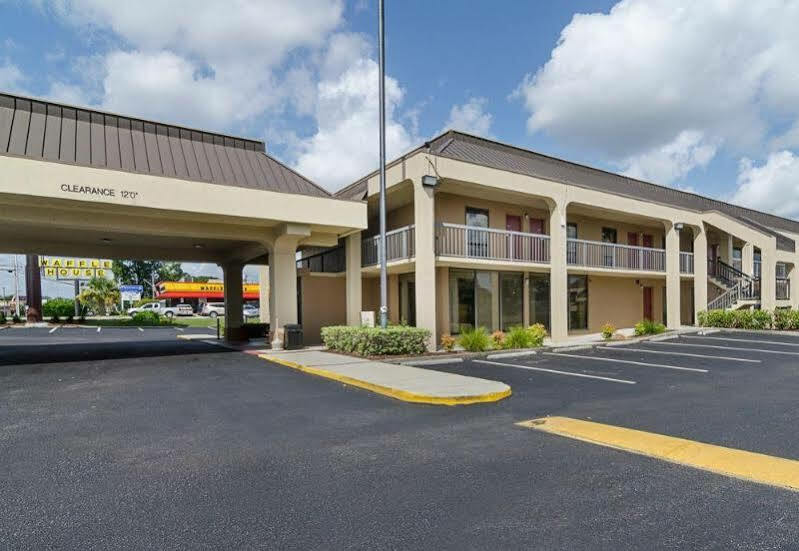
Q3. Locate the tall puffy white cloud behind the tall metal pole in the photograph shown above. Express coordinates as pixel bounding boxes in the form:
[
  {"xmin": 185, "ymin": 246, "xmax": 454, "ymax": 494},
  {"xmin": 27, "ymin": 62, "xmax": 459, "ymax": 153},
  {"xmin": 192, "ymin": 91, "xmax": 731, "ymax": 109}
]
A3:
[{"xmin": 295, "ymin": 34, "xmax": 415, "ymax": 190}]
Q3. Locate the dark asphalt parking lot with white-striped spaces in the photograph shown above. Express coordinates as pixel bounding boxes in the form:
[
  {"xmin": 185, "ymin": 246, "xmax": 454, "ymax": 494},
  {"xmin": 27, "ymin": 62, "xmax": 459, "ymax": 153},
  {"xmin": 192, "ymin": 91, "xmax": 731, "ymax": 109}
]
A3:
[{"xmin": 0, "ymin": 329, "xmax": 799, "ymax": 549}]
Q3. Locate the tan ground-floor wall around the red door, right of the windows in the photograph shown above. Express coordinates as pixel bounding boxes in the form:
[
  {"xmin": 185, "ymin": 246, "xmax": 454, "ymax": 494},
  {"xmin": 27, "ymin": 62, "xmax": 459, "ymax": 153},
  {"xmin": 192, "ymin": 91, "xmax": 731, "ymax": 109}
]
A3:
[{"xmin": 588, "ymin": 275, "xmax": 666, "ymax": 333}]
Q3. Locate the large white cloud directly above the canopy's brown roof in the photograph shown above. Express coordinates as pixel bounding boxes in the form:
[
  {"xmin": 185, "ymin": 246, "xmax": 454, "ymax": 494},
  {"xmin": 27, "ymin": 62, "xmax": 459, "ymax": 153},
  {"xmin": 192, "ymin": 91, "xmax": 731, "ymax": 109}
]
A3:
[{"xmin": 50, "ymin": 0, "xmax": 343, "ymax": 130}]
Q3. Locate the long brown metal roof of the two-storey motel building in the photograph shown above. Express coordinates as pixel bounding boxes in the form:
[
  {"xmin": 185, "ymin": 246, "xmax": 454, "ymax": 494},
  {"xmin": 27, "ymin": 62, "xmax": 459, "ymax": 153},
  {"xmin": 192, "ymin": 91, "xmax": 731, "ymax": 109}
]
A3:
[{"xmin": 336, "ymin": 130, "xmax": 799, "ymax": 252}]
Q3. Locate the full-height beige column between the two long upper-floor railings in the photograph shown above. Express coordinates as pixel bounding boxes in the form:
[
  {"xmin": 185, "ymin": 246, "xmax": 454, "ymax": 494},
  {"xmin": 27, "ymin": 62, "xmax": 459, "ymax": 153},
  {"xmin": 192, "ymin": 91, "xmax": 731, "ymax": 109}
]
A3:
[{"xmin": 549, "ymin": 201, "xmax": 569, "ymax": 341}]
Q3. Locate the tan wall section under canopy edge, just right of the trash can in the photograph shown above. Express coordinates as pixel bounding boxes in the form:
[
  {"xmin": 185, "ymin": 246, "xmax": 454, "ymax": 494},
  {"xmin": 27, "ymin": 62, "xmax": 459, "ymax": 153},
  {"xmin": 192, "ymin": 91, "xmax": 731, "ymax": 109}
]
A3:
[{"xmin": 300, "ymin": 274, "xmax": 347, "ymax": 344}]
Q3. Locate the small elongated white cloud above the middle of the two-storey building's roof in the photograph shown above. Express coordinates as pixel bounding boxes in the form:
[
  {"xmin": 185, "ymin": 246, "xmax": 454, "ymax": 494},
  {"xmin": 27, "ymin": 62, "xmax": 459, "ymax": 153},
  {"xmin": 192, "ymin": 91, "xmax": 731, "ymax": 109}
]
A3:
[{"xmin": 619, "ymin": 130, "xmax": 718, "ymax": 183}]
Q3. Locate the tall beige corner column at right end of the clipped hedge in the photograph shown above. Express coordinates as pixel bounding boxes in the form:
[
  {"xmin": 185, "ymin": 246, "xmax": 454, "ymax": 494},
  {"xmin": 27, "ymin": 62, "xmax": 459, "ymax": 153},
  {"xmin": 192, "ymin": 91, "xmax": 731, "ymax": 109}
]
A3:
[{"xmin": 413, "ymin": 182, "xmax": 438, "ymax": 350}]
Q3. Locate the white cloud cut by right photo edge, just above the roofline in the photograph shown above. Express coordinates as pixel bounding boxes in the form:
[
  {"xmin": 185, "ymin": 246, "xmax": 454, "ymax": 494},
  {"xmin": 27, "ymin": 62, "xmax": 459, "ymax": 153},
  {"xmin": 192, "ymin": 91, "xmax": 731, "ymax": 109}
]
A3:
[{"xmin": 731, "ymin": 151, "xmax": 799, "ymax": 218}]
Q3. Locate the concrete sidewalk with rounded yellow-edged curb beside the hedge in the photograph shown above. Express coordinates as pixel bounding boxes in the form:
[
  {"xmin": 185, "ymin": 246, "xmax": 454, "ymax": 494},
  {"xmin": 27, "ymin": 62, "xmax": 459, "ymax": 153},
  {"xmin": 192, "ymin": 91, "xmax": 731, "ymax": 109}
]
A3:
[{"xmin": 259, "ymin": 350, "xmax": 511, "ymax": 405}]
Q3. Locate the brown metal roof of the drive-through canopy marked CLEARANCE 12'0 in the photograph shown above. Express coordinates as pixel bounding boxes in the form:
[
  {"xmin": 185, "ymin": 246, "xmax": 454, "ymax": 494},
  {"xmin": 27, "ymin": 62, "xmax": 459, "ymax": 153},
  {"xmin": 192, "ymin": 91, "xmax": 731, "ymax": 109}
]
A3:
[{"xmin": 0, "ymin": 94, "xmax": 330, "ymax": 197}]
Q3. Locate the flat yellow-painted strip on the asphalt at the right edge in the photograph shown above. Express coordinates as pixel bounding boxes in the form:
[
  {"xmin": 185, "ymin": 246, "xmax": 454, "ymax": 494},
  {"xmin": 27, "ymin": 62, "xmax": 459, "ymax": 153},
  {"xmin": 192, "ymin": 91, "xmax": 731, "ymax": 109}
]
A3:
[{"xmin": 516, "ymin": 417, "xmax": 799, "ymax": 490}]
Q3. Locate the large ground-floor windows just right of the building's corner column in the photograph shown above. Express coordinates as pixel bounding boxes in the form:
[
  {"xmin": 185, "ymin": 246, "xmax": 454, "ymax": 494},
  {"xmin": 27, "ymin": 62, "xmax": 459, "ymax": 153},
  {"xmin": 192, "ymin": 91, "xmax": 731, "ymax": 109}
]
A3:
[{"xmin": 449, "ymin": 269, "xmax": 524, "ymax": 334}]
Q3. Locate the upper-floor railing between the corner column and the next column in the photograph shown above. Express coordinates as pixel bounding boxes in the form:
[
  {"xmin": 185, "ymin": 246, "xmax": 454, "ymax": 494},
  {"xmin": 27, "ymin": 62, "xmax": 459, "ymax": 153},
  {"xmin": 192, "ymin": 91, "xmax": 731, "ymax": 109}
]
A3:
[{"xmin": 436, "ymin": 223, "xmax": 549, "ymax": 263}]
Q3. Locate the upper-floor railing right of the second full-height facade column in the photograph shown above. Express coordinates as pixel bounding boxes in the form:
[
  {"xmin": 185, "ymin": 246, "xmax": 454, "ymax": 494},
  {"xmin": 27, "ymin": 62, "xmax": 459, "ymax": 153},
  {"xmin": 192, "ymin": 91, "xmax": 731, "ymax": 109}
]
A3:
[{"xmin": 566, "ymin": 239, "xmax": 666, "ymax": 272}]
